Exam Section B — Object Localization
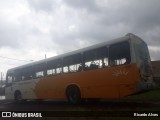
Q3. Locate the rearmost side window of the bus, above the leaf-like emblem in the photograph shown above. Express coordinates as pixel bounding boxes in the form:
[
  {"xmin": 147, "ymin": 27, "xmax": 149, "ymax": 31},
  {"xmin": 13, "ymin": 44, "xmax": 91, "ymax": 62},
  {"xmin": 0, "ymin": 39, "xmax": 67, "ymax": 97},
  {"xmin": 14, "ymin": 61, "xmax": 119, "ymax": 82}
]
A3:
[{"xmin": 109, "ymin": 42, "xmax": 131, "ymax": 66}]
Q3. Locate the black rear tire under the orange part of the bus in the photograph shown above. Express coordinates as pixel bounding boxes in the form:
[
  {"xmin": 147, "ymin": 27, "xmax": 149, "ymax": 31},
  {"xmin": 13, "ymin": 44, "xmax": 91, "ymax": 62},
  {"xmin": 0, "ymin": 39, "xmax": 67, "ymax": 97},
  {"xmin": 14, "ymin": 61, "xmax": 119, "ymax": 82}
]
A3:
[{"xmin": 66, "ymin": 85, "xmax": 81, "ymax": 105}]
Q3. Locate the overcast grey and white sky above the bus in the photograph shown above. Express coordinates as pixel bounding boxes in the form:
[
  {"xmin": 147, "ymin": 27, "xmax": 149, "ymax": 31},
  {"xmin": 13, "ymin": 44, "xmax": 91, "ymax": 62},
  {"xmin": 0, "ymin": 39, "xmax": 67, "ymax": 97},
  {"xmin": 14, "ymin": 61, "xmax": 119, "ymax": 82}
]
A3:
[{"xmin": 0, "ymin": 0, "xmax": 160, "ymax": 78}]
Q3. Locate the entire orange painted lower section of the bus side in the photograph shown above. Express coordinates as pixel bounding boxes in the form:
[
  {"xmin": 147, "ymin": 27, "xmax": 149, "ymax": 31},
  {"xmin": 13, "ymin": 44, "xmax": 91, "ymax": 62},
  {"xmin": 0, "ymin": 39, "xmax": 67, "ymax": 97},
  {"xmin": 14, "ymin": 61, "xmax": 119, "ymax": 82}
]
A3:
[{"xmin": 35, "ymin": 64, "xmax": 140, "ymax": 99}]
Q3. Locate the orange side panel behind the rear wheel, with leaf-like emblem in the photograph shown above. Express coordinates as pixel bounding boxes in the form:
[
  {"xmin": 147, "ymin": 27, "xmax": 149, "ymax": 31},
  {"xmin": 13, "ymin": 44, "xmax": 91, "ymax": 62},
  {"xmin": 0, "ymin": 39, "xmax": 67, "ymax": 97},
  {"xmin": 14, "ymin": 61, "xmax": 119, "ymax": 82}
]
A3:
[{"xmin": 80, "ymin": 64, "xmax": 140, "ymax": 98}]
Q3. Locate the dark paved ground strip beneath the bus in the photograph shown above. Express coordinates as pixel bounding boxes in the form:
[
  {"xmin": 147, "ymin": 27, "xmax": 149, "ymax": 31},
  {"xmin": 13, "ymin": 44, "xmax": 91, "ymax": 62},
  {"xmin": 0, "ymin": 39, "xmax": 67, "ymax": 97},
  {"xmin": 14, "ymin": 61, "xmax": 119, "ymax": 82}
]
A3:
[{"xmin": 0, "ymin": 100, "xmax": 160, "ymax": 111}]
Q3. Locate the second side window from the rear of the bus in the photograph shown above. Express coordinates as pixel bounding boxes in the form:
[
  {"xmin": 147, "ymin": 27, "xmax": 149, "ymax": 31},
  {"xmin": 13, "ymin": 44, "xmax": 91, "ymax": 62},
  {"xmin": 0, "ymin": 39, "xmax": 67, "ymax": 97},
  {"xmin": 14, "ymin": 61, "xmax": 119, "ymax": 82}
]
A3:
[{"xmin": 83, "ymin": 47, "xmax": 108, "ymax": 70}]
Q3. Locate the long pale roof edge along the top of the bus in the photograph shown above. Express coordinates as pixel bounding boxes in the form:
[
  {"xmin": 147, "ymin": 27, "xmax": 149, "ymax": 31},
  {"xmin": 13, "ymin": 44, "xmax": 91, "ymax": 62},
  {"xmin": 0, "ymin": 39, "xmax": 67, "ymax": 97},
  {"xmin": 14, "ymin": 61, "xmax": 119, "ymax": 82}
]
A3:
[{"xmin": 8, "ymin": 33, "xmax": 142, "ymax": 72}]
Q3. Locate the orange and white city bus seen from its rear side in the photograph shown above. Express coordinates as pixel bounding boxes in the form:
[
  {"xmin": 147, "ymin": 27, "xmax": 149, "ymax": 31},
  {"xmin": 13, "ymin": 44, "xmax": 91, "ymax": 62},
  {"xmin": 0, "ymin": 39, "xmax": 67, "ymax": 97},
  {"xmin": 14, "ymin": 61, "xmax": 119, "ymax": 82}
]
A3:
[{"xmin": 5, "ymin": 33, "xmax": 154, "ymax": 104}]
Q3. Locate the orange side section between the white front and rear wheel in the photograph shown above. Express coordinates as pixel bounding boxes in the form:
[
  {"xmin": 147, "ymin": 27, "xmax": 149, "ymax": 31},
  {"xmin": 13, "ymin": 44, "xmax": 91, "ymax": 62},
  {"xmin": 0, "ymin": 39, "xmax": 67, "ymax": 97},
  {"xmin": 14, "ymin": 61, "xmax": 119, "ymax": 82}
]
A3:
[{"xmin": 35, "ymin": 75, "xmax": 69, "ymax": 99}]
